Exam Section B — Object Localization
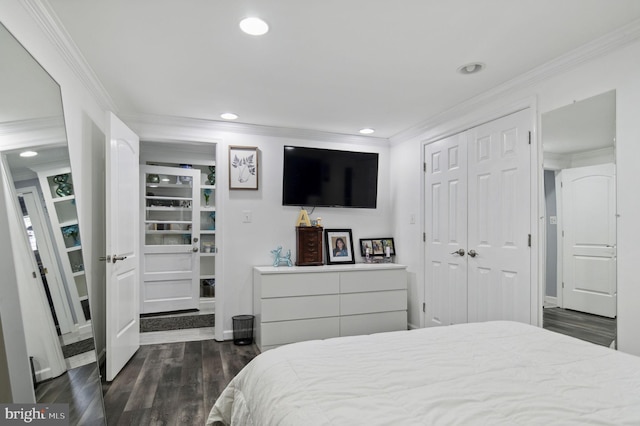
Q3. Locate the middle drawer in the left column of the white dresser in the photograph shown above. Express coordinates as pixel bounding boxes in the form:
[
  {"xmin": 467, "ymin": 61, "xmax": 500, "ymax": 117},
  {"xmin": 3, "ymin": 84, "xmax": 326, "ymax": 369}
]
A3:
[{"xmin": 262, "ymin": 294, "xmax": 340, "ymax": 322}]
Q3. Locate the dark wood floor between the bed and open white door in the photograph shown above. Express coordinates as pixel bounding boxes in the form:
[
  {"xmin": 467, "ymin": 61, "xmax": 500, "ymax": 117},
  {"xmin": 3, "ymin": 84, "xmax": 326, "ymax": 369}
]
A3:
[{"xmin": 103, "ymin": 340, "xmax": 259, "ymax": 426}]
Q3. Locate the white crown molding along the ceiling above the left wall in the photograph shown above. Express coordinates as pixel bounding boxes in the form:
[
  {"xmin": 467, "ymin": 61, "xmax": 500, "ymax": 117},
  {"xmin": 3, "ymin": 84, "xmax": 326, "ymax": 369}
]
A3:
[{"xmin": 21, "ymin": 0, "xmax": 117, "ymax": 112}]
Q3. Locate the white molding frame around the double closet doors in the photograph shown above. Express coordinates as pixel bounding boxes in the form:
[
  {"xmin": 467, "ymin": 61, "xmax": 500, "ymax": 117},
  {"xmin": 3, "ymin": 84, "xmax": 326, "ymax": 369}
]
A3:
[{"xmin": 420, "ymin": 96, "xmax": 545, "ymax": 327}]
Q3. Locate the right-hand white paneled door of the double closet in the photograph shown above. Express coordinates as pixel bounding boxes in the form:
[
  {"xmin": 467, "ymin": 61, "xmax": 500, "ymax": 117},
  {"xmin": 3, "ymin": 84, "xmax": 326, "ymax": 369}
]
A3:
[{"xmin": 467, "ymin": 110, "xmax": 531, "ymax": 323}]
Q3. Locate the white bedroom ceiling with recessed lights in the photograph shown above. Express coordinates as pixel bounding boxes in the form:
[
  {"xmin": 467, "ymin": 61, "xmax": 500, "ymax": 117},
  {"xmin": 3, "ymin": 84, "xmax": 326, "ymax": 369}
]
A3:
[{"xmin": 48, "ymin": 0, "xmax": 640, "ymax": 138}]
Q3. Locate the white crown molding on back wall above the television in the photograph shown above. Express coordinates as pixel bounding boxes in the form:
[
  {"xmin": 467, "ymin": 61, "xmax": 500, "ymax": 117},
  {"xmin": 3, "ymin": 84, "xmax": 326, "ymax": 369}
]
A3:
[{"xmin": 120, "ymin": 114, "xmax": 389, "ymax": 146}]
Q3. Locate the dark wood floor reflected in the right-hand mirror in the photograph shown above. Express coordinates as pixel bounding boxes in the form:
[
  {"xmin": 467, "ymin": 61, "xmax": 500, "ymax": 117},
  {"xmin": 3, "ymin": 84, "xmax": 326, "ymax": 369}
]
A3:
[{"xmin": 543, "ymin": 308, "xmax": 616, "ymax": 346}]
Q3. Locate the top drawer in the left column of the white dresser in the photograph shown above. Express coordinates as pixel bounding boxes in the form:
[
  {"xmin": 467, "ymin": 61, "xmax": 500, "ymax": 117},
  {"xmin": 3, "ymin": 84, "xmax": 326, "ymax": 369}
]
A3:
[{"xmin": 260, "ymin": 272, "xmax": 340, "ymax": 299}]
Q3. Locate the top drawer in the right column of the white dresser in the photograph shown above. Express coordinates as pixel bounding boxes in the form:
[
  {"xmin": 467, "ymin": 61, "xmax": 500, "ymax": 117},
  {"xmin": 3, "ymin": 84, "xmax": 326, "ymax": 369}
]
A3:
[{"xmin": 340, "ymin": 269, "xmax": 407, "ymax": 293}]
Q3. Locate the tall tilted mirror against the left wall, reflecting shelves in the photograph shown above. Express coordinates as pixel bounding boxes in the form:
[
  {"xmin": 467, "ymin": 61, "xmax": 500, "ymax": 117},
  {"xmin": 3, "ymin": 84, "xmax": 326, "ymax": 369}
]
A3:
[{"xmin": 0, "ymin": 19, "xmax": 104, "ymax": 424}]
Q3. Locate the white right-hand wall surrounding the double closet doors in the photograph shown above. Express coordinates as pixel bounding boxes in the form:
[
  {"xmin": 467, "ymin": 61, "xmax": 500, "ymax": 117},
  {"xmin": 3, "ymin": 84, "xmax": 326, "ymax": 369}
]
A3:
[{"xmin": 391, "ymin": 42, "xmax": 640, "ymax": 355}]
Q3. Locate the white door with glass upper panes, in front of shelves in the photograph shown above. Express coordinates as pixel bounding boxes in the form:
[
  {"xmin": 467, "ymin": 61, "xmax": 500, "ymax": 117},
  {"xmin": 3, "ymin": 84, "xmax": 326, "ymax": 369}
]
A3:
[{"xmin": 140, "ymin": 166, "xmax": 200, "ymax": 313}]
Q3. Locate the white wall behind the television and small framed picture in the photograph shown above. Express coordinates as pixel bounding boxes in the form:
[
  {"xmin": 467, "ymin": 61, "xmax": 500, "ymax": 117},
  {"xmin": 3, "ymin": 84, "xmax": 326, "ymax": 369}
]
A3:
[{"xmin": 131, "ymin": 118, "xmax": 393, "ymax": 339}]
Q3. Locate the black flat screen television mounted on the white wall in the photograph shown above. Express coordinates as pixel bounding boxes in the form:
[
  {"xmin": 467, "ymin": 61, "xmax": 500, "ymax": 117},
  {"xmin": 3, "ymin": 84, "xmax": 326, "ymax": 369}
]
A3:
[{"xmin": 282, "ymin": 146, "xmax": 378, "ymax": 209}]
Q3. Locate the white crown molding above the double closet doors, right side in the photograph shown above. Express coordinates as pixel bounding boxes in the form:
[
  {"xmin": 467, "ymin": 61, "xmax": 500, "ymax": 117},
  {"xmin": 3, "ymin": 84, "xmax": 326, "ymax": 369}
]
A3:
[{"xmin": 389, "ymin": 19, "xmax": 640, "ymax": 146}]
